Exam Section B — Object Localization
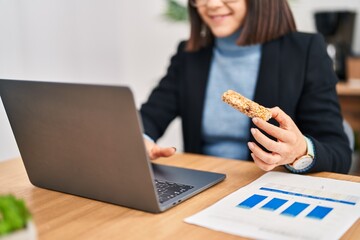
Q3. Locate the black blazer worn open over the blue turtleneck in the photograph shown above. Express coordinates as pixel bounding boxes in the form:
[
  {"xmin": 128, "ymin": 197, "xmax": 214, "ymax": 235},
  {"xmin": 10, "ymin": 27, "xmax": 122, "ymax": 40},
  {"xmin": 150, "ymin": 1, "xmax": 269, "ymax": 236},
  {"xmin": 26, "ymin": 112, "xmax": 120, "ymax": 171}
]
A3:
[{"xmin": 140, "ymin": 32, "xmax": 351, "ymax": 173}]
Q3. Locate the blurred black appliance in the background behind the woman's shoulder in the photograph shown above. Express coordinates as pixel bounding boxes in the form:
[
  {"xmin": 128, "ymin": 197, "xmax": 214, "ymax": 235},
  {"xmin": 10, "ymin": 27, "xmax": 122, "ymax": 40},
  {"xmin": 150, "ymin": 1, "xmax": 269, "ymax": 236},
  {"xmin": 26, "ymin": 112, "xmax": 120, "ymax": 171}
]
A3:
[{"xmin": 315, "ymin": 11, "xmax": 356, "ymax": 81}]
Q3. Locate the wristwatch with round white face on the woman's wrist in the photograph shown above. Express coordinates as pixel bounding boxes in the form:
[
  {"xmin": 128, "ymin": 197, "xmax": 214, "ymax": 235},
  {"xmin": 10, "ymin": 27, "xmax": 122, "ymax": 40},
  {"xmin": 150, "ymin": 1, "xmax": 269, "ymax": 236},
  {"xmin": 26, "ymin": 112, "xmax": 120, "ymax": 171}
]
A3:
[{"xmin": 285, "ymin": 136, "xmax": 315, "ymax": 173}]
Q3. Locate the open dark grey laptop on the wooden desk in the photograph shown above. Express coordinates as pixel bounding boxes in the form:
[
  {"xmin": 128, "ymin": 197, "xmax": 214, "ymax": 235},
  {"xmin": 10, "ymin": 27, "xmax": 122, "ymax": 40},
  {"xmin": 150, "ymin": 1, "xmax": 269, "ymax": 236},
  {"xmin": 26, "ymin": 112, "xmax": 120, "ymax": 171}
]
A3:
[{"xmin": 0, "ymin": 80, "xmax": 226, "ymax": 213}]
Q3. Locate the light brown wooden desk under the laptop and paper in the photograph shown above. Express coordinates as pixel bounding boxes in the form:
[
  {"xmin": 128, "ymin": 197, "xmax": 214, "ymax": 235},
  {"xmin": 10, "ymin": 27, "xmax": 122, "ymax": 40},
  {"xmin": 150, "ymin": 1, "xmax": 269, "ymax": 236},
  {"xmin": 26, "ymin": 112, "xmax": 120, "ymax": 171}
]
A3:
[{"xmin": 0, "ymin": 154, "xmax": 360, "ymax": 240}]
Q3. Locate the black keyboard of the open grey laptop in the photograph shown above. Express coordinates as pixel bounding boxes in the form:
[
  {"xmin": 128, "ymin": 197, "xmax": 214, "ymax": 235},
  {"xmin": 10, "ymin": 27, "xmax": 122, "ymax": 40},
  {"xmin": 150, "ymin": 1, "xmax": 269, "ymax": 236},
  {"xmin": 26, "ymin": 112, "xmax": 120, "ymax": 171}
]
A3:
[{"xmin": 155, "ymin": 180, "xmax": 194, "ymax": 203}]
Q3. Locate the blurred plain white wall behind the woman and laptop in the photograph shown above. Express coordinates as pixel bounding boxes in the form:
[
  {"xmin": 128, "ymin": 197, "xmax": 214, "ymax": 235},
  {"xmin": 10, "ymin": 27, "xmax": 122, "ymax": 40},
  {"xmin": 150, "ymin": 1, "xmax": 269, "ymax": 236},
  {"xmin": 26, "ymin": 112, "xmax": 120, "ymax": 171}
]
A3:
[{"xmin": 0, "ymin": 0, "xmax": 360, "ymax": 172}]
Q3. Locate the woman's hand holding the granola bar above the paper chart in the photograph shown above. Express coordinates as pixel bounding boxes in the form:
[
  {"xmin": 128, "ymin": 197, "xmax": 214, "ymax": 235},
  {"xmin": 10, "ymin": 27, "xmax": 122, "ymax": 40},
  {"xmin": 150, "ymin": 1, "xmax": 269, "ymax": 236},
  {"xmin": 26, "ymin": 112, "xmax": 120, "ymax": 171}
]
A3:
[{"xmin": 248, "ymin": 107, "xmax": 307, "ymax": 171}]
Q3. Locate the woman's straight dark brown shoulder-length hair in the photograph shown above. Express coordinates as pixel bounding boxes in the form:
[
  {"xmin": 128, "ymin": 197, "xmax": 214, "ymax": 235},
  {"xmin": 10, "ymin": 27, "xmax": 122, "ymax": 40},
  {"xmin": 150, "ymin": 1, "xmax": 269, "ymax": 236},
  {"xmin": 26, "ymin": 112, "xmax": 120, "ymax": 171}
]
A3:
[{"xmin": 186, "ymin": 0, "xmax": 296, "ymax": 52}]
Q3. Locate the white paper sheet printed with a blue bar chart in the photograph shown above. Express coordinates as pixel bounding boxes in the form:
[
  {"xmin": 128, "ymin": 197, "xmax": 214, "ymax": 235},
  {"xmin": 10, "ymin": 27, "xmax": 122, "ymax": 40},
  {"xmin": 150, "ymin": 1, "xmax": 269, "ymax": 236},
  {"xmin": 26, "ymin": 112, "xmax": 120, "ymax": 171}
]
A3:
[{"xmin": 185, "ymin": 172, "xmax": 360, "ymax": 240}]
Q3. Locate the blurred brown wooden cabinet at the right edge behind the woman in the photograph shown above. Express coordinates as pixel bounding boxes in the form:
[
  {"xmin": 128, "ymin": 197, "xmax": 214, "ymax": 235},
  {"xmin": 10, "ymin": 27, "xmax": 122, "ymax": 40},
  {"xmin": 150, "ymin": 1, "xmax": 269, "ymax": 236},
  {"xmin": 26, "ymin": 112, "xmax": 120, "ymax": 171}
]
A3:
[{"xmin": 336, "ymin": 80, "xmax": 360, "ymax": 132}]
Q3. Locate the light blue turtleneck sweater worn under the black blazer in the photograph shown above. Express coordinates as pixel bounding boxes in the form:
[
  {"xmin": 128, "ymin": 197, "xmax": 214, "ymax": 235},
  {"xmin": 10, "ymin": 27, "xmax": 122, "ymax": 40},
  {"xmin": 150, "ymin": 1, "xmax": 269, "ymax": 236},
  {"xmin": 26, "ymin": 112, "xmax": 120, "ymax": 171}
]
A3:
[{"xmin": 202, "ymin": 32, "xmax": 261, "ymax": 159}]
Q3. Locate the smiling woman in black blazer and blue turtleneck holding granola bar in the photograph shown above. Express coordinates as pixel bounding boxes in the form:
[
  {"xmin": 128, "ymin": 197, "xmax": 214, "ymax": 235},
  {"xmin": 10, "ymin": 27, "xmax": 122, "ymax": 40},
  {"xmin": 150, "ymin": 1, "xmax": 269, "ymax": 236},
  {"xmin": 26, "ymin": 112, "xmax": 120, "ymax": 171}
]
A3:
[{"xmin": 140, "ymin": 0, "xmax": 351, "ymax": 173}]
